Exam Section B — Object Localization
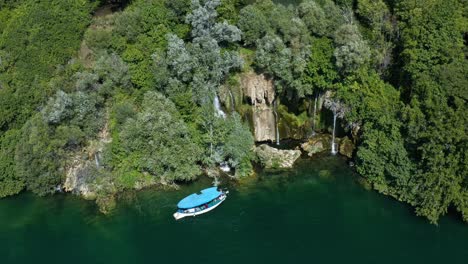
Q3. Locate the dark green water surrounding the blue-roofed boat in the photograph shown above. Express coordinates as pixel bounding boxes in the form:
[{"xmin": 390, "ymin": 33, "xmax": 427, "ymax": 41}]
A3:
[{"xmin": 0, "ymin": 157, "xmax": 468, "ymax": 264}]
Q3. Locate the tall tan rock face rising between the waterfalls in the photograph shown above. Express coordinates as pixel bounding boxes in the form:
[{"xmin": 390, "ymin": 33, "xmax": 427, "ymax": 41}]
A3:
[{"xmin": 241, "ymin": 73, "xmax": 276, "ymax": 142}]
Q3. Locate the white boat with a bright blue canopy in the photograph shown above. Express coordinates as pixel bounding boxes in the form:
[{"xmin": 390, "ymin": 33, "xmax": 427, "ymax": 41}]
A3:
[{"xmin": 174, "ymin": 187, "xmax": 229, "ymax": 220}]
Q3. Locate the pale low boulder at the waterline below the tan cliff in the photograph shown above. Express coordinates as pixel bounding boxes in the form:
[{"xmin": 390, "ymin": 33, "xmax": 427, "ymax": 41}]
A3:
[{"xmin": 255, "ymin": 144, "xmax": 301, "ymax": 169}]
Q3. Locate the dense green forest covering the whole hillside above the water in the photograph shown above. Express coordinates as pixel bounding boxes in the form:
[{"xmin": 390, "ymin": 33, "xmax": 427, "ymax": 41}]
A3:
[{"xmin": 0, "ymin": 0, "xmax": 468, "ymax": 223}]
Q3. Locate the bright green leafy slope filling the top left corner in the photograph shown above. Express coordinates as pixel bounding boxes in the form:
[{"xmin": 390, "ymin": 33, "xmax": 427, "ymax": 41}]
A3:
[{"xmin": 0, "ymin": 0, "xmax": 93, "ymax": 130}]
